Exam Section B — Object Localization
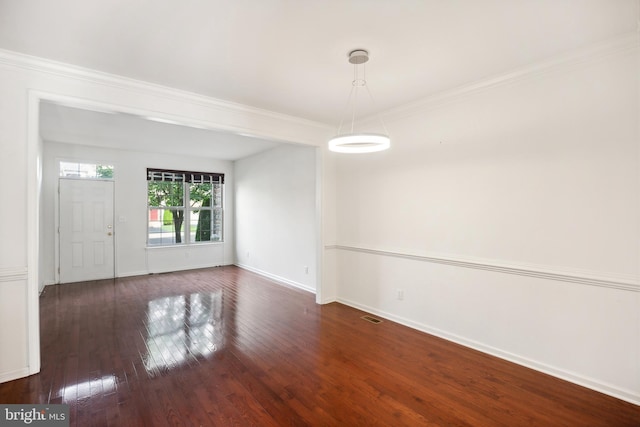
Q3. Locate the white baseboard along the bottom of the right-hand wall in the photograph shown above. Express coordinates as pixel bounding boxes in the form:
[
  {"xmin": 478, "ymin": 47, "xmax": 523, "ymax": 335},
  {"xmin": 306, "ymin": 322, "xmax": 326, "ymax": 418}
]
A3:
[{"xmin": 337, "ymin": 298, "xmax": 640, "ymax": 405}]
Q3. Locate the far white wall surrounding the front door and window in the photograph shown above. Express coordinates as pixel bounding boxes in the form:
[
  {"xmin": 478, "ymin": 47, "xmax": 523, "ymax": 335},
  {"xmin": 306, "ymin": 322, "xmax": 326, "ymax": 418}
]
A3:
[{"xmin": 41, "ymin": 141, "xmax": 234, "ymax": 284}]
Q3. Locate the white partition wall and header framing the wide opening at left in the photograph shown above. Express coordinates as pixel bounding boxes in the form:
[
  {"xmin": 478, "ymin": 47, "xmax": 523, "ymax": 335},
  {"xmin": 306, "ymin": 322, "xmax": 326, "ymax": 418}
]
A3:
[{"xmin": 0, "ymin": 51, "xmax": 330, "ymax": 382}]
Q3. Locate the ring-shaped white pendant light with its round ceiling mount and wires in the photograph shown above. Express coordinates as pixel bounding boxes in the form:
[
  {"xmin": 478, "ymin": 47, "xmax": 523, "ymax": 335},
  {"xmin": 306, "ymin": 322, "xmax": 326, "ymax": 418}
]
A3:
[{"xmin": 329, "ymin": 49, "xmax": 391, "ymax": 153}]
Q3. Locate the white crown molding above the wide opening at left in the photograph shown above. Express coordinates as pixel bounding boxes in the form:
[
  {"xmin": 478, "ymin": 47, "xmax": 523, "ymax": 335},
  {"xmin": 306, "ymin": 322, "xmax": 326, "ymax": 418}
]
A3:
[{"xmin": 0, "ymin": 49, "xmax": 330, "ymax": 130}]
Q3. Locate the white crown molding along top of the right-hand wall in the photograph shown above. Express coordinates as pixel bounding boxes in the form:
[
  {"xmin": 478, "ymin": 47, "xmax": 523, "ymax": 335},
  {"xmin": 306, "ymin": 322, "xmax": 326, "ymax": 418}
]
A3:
[{"xmin": 372, "ymin": 32, "xmax": 640, "ymax": 122}]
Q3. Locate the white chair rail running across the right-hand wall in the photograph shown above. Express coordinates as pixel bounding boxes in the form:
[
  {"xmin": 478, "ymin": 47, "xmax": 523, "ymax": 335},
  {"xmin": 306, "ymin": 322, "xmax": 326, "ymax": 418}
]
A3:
[{"xmin": 325, "ymin": 245, "xmax": 640, "ymax": 292}]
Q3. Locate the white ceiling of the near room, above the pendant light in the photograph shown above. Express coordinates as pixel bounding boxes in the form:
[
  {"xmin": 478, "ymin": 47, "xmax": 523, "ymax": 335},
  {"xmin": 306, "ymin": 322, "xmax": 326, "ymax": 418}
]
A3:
[{"xmin": 0, "ymin": 0, "xmax": 638, "ymax": 159}]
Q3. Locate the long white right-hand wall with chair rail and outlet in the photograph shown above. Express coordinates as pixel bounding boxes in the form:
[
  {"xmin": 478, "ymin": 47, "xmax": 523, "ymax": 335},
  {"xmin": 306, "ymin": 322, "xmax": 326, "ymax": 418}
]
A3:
[{"xmin": 333, "ymin": 44, "xmax": 640, "ymax": 403}]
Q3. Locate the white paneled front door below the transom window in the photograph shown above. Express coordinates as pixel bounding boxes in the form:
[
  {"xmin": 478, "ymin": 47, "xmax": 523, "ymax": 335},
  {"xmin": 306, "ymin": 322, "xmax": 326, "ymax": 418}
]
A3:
[{"xmin": 59, "ymin": 179, "xmax": 115, "ymax": 283}]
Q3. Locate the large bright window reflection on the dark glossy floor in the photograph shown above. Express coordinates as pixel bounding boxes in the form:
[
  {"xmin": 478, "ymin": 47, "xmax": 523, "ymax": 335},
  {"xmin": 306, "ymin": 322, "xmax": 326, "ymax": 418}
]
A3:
[{"xmin": 141, "ymin": 290, "xmax": 224, "ymax": 375}]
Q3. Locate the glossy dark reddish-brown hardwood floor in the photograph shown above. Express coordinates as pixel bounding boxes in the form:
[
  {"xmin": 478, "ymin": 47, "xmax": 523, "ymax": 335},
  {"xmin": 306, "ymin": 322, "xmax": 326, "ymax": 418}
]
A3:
[{"xmin": 0, "ymin": 267, "xmax": 640, "ymax": 427}]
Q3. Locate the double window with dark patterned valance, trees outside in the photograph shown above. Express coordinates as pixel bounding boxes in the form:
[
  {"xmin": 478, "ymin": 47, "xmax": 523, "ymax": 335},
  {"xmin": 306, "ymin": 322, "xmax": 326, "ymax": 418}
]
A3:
[{"xmin": 147, "ymin": 169, "xmax": 224, "ymax": 246}]
